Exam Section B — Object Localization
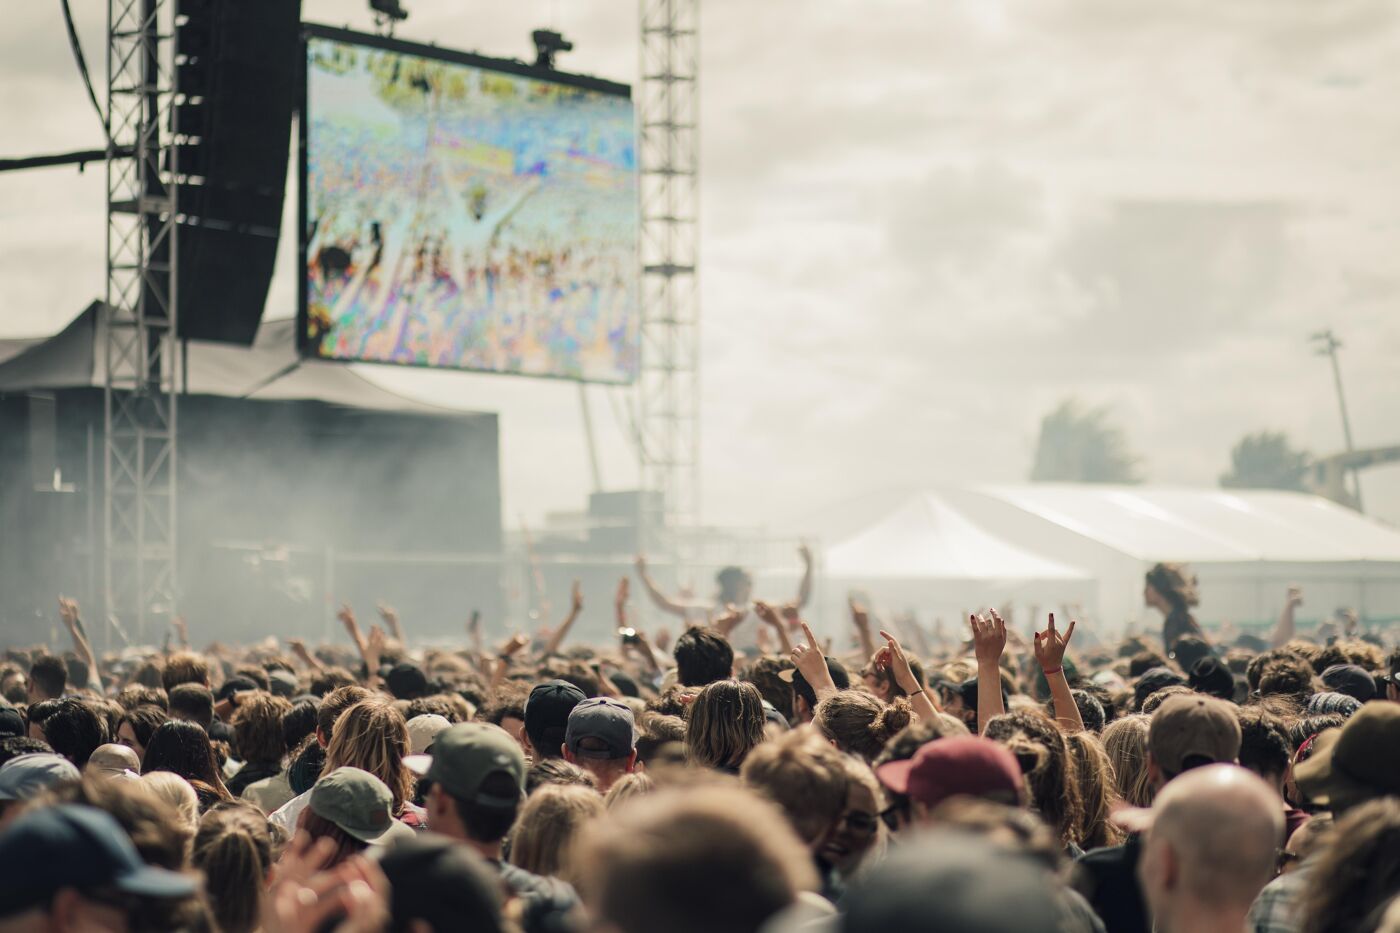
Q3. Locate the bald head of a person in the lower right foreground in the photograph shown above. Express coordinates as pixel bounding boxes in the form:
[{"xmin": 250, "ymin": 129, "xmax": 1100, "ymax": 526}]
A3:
[{"xmin": 1140, "ymin": 765, "xmax": 1284, "ymax": 929}]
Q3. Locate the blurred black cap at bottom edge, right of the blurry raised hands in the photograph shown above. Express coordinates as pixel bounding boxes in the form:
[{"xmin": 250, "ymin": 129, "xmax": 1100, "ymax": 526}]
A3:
[{"xmin": 379, "ymin": 834, "xmax": 501, "ymax": 930}]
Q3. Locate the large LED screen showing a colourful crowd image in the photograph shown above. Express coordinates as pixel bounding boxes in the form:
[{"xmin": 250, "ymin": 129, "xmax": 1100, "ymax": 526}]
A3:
[{"xmin": 301, "ymin": 27, "xmax": 640, "ymax": 382}]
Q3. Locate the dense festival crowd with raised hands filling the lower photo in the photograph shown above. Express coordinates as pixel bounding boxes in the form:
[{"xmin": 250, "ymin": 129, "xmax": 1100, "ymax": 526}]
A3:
[{"xmin": 0, "ymin": 563, "xmax": 1400, "ymax": 933}]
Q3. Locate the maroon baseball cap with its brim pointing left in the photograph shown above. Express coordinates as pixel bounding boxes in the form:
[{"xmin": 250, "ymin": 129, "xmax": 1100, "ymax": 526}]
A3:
[{"xmin": 875, "ymin": 735, "xmax": 1025, "ymax": 807}]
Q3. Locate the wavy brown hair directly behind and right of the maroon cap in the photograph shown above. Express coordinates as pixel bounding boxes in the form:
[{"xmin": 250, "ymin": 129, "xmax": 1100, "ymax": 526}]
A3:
[{"xmin": 986, "ymin": 709, "xmax": 1084, "ymax": 845}]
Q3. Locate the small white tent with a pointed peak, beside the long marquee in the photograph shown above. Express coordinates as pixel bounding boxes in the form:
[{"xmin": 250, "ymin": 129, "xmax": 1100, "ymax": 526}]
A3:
[{"xmin": 823, "ymin": 493, "xmax": 1096, "ymax": 622}]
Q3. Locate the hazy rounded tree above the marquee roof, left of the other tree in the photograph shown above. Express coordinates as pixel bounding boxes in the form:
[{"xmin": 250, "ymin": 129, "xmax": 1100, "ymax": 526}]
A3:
[{"xmin": 1030, "ymin": 398, "xmax": 1141, "ymax": 483}]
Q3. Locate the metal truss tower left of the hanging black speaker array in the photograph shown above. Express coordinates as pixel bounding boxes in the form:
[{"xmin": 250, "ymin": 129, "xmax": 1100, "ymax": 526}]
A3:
[{"xmin": 98, "ymin": 0, "xmax": 179, "ymax": 636}]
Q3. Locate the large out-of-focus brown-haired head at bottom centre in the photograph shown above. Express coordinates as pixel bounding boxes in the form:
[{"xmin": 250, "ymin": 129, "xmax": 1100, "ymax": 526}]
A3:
[{"xmin": 573, "ymin": 784, "xmax": 817, "ymax": 933}]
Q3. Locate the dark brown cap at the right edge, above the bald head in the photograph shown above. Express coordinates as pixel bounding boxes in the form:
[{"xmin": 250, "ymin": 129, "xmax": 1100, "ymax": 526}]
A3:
[{"xmin": 1294, "ymin": 703, "xmax": 1400, "ymax": 810}]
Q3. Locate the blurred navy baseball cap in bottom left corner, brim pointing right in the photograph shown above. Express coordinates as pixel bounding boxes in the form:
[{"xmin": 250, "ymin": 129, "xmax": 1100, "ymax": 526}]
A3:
[{"xmin": 0, "ymin": 804, "xmax": 197, "ymax": 916}]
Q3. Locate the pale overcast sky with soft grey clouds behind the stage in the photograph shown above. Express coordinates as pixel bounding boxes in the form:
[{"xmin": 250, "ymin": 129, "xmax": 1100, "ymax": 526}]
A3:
[{"xmin": 0, "ymin": 0, "xmax": 1400, "ymax": 531}]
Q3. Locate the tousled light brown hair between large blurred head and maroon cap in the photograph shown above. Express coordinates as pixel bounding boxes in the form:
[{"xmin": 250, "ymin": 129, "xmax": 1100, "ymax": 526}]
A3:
[{"xmin": 739, "ymin": 728, "xmax": 850, "ymax": 843}]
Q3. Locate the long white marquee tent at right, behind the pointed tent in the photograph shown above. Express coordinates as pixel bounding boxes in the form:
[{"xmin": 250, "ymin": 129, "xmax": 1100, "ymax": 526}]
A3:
[{"xmin": 948, "ymin": 483, "xmax": 1400, "ymax": 626}]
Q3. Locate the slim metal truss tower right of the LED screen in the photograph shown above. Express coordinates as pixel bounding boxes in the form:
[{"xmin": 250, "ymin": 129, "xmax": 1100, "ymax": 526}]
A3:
[{"xmin": 638, "ymin": 0, "xmax": 700, "ymax": 562}]
